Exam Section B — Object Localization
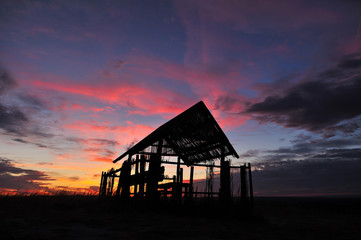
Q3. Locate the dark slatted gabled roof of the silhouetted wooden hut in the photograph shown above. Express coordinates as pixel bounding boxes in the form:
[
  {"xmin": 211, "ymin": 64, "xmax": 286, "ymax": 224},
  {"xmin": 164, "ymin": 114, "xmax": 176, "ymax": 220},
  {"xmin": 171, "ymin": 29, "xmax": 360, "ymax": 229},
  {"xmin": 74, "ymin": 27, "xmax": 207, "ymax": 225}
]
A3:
[{"xmin": 113, "ymin": 101, "xmax": 239, "ymax": 165}]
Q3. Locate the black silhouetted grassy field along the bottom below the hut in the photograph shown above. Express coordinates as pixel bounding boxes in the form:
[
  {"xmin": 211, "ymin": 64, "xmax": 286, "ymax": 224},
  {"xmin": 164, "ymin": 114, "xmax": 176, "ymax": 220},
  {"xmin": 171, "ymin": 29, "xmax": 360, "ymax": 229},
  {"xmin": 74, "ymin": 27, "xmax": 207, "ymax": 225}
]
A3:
[{"xmin": 0, "ymin": 195, "xmax": 361, "ymax": 240}]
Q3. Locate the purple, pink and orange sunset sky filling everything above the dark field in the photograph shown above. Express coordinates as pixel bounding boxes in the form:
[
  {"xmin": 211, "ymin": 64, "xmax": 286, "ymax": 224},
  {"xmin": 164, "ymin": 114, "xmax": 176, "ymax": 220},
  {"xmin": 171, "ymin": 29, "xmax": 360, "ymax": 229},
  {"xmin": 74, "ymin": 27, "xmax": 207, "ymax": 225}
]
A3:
[{"xmin": 0, "ymin": 0, "xmax": 361, "ymax": 196}]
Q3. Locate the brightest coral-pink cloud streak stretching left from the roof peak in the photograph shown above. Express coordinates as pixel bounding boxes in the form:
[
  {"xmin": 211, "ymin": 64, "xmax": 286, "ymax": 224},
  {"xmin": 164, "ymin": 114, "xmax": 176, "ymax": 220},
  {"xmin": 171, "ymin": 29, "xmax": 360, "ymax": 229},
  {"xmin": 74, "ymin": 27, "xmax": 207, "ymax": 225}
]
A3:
[{"xmin": 31, "ymin": 72, "xmax": 193, "ymax": 115}]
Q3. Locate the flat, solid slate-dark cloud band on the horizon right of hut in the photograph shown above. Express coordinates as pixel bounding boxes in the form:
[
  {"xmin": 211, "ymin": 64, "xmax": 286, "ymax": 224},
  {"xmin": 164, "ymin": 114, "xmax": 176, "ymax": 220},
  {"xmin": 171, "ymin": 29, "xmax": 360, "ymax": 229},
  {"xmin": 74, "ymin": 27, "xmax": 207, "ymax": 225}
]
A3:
[{"xmin": 253, "ymin": 158, "xmax": 361, "ymax": 196}]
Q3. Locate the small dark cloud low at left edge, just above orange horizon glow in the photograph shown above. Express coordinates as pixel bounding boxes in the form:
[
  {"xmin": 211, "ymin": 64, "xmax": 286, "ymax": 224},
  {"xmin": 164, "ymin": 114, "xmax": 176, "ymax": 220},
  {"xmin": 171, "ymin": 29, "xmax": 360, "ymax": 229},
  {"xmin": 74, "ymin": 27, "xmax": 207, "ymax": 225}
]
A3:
[{"xmin": 0, "ymin": 157, "xmax": 54, "ymax": 191}]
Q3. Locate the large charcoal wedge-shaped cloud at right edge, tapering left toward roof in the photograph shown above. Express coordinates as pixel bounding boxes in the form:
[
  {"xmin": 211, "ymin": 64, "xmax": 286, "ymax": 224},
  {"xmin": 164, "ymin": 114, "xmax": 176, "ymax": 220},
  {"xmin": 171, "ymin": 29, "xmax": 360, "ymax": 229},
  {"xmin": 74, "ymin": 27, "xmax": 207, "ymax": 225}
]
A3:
[{"xmin": 245, "ymin": 53, "xmax": 361, "ymax": 136}]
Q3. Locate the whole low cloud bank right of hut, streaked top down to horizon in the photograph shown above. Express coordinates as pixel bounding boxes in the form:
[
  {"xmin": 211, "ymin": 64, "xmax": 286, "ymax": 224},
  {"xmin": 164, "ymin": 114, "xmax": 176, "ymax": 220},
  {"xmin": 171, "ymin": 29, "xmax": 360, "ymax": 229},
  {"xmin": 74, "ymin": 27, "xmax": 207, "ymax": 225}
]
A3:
[{"xmin": 236, "ymin": 132, "xmax": 361, "ymax": 196}]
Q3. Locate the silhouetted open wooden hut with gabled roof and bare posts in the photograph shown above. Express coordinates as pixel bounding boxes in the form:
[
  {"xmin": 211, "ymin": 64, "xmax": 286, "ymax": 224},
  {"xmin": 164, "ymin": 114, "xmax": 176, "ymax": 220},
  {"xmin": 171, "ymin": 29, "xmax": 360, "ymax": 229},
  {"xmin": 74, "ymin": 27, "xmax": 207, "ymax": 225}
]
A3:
[{"xmin": 99, "ymin": 102, "xmax": 253, "ymax": 207}]
